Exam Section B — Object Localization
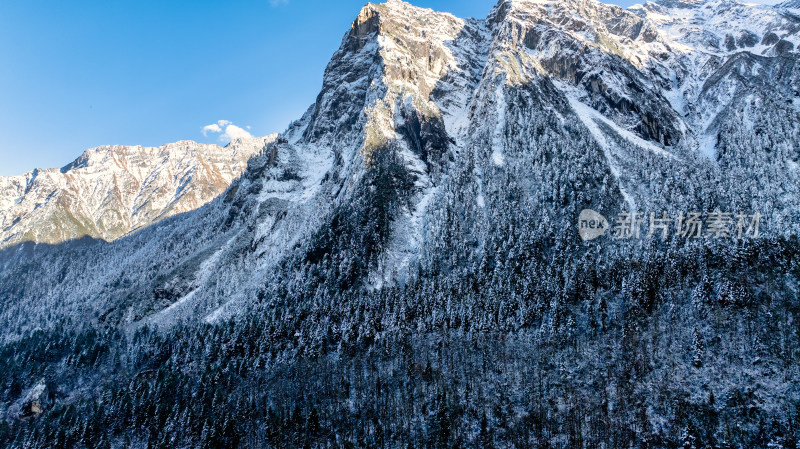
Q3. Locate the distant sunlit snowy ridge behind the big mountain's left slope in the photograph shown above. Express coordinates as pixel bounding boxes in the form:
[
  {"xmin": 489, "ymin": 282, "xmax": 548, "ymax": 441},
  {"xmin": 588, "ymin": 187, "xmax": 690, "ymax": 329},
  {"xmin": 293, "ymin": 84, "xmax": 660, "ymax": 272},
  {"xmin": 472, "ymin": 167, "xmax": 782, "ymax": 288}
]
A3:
[{"xmin": 0, "ymin": 135, "xmax": 277, "ymax": 247}]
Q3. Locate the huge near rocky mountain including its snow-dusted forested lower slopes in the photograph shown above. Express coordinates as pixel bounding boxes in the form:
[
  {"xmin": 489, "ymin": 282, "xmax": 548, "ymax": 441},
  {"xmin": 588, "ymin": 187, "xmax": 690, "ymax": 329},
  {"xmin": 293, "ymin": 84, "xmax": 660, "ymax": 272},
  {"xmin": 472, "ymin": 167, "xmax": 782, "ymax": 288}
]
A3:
[{"xmin": 0, "ymin": 0, "xmax": 800, "ymax": 447}]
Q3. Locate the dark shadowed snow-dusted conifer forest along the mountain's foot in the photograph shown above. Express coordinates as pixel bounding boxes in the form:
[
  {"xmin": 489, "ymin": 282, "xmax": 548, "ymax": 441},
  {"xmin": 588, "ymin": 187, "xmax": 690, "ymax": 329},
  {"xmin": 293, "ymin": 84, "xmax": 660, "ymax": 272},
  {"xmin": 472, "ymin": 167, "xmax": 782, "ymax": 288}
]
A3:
[{"xmin": 0, "ymin": 233, "xmax": 800, "ymax": 448}]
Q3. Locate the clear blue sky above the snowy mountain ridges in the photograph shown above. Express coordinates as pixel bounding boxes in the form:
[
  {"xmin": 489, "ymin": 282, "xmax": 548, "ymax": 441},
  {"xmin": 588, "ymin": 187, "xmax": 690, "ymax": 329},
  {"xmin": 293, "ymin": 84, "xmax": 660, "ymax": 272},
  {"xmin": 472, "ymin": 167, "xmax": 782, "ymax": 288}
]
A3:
[{"xmin": 0, "ymin": 0, "xmax": 768, "ymax": 175}]
